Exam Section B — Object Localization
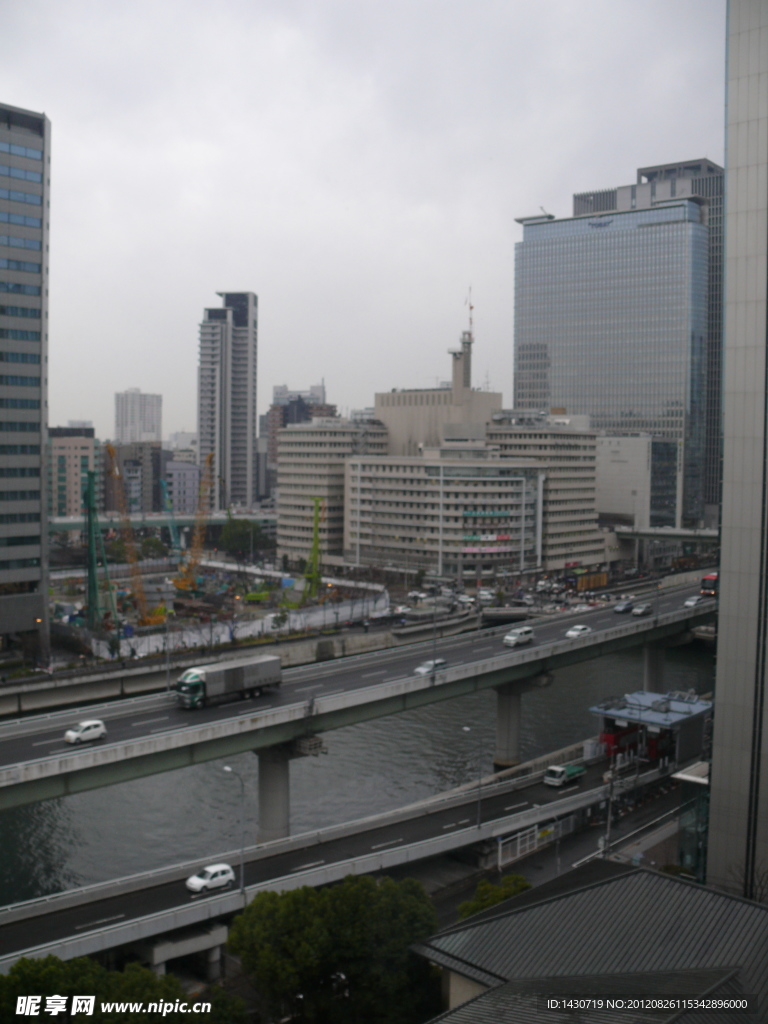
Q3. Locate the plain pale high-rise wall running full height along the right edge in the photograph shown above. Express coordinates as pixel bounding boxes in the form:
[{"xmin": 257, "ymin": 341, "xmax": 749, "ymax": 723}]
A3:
[{"xmin": 707, "ymin": 0, "xmax": 768, "ymax": 897}]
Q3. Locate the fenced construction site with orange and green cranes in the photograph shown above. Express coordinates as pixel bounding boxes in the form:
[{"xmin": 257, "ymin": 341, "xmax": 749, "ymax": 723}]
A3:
[{"xmin": 45, "ymin": 444, "xmax": 389, "ymax": 664}]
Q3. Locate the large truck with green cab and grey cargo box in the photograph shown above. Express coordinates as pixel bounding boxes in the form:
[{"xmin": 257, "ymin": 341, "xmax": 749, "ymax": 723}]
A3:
[{"xmin": 176, "ymin": 654, "xmax": 283, "ymax": 708}]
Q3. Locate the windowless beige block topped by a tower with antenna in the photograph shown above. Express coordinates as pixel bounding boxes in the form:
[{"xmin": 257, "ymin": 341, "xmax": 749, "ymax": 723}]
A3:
[{"xmin": 374, "ymin": 331, "xmax": 503, "ymax": 455}]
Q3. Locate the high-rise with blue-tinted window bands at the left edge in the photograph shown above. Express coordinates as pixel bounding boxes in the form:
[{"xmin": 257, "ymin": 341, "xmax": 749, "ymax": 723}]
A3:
[{"xmin": 0, "ymin": 104, "xmax": 50, "ymax": 660}]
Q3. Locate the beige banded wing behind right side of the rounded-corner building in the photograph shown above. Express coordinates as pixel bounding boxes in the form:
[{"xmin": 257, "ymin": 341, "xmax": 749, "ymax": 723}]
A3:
[{"xmin": 486, "ymin": 412, "xmax": 606, "ymax": 571}]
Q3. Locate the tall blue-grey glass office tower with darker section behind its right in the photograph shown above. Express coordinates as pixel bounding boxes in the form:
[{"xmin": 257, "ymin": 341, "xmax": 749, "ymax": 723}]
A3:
[{"xmin": 515, "ymin": 167, "xmax": 722, "ymax": 525}]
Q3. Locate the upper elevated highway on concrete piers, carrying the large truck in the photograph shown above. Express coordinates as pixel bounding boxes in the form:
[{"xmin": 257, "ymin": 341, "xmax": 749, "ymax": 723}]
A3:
[{"xmin": 0, "ymin": 594, "xmax": 716, "ymax": 819}]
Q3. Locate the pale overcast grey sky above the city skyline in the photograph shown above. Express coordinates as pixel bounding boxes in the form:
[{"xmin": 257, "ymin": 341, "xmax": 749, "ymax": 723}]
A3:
[{"xmin": 0, "ymin": 0, "xmax": 725, "ymax": 437}]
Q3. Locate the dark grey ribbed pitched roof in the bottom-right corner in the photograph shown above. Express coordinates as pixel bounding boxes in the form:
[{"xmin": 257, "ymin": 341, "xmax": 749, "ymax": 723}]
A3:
[{"xmin": 414, "ymin": 868, "xmax": 768, "ymax": 1024}]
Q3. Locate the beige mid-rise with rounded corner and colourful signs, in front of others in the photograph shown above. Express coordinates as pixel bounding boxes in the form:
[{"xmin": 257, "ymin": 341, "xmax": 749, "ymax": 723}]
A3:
[{"xmin": 344, "ymin": 445, "xmax": 545, "ymax": 583}]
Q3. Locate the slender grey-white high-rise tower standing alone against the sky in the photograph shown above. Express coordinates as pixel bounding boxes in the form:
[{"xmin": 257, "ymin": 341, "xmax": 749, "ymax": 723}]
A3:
[{"xmin": 198, "ymin": 292, "xmax": 258, "ymax": 509}]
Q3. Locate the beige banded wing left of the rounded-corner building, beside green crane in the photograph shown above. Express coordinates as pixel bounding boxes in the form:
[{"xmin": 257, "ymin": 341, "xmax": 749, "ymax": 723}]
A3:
[{"xmin": 276, "ymin": 419, "xmax": 387, "ymax": 565}]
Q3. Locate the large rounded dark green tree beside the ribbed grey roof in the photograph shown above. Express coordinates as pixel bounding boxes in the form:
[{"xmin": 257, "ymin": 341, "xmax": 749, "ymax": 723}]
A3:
[{"xmin": 229, "ymin": 876, "xmax": 439, "ymax": 1024}]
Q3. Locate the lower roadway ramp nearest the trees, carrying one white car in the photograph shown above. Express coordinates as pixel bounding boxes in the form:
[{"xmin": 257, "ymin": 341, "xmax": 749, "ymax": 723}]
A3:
[{"xmin": 0, "ymin": 748, "xmax": 673, "ymax": 972}]
